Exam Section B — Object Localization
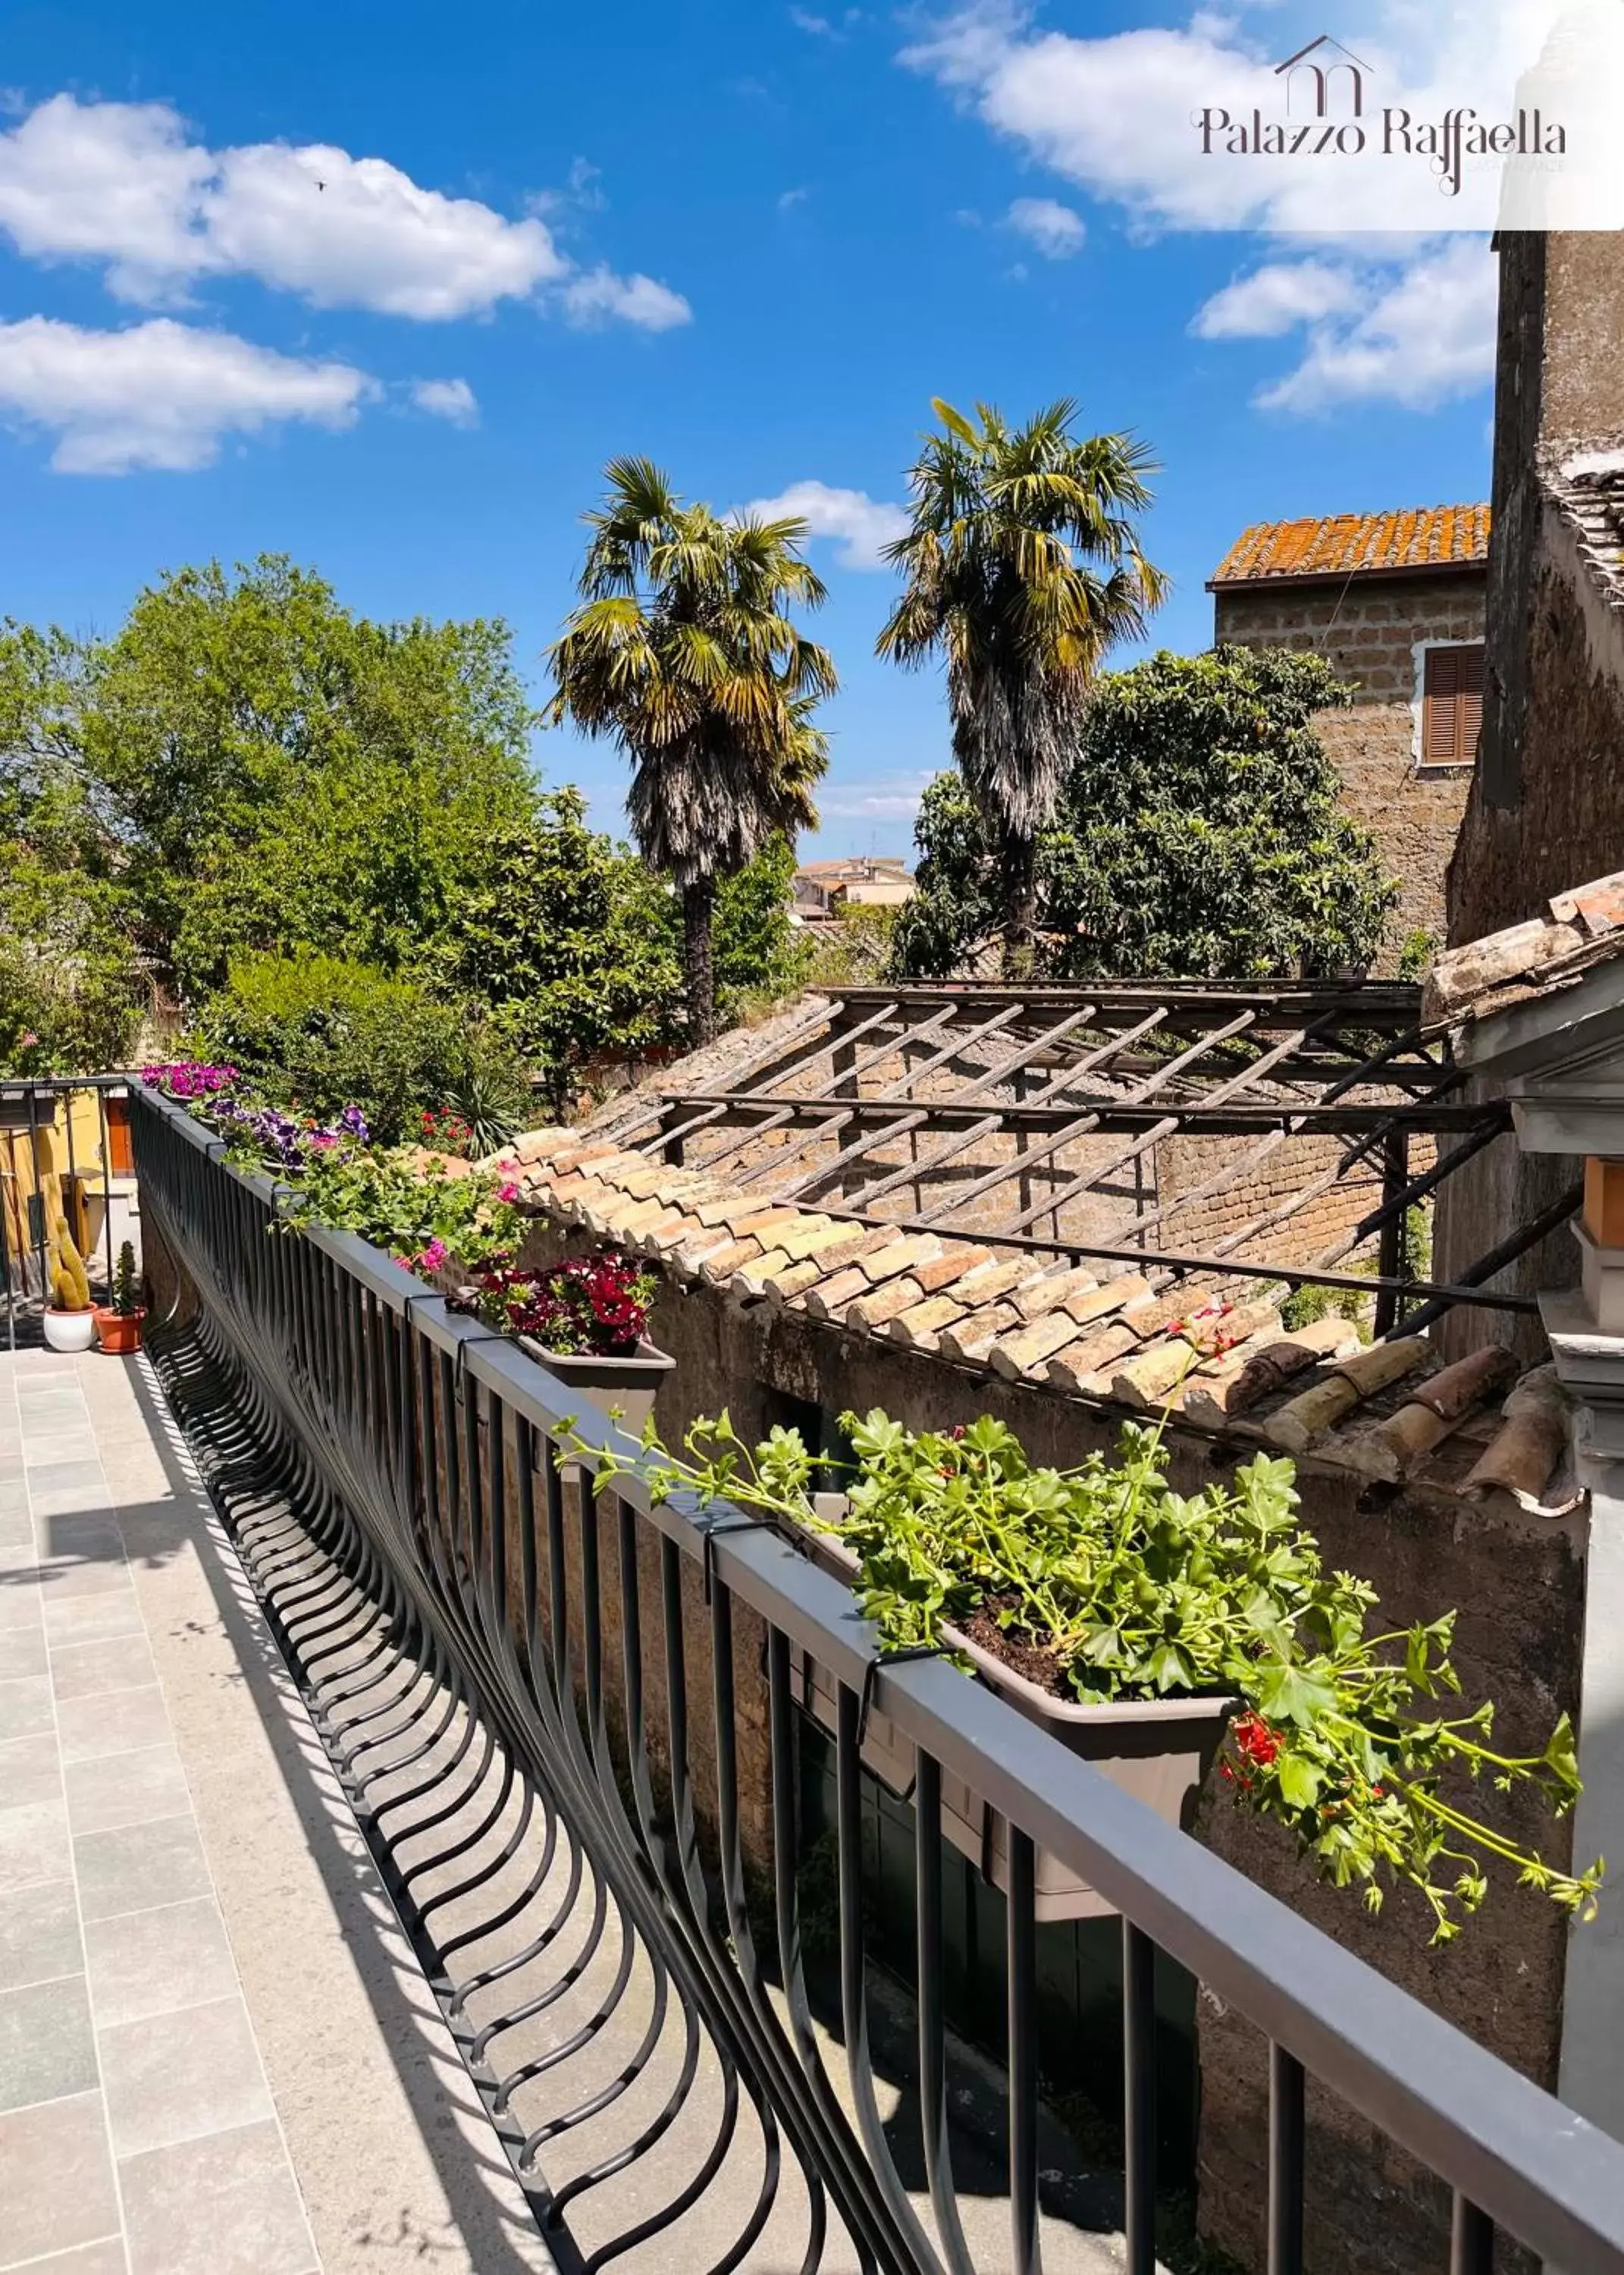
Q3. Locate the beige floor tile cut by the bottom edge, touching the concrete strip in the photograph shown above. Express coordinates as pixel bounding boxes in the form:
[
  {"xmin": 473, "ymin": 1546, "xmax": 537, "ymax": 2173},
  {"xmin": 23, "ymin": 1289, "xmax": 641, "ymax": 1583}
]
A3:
[{"xmin": 118, "ymin": 2125, "xmax": 316, "ymax": 2275}]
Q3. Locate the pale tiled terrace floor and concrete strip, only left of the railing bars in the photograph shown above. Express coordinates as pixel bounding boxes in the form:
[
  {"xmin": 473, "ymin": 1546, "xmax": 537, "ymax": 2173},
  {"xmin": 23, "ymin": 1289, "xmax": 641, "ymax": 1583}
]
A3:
[{"xmin": 0, "ymin": 1351, "xmax": 553, "ymax": 2275}]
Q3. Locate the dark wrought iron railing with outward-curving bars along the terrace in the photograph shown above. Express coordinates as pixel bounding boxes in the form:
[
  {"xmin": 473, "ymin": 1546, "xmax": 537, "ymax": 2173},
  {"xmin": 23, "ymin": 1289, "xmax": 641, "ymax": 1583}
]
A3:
[{"xmin": 134, "ymin": 1094, "xmax": 1624, "ymax": 2275}]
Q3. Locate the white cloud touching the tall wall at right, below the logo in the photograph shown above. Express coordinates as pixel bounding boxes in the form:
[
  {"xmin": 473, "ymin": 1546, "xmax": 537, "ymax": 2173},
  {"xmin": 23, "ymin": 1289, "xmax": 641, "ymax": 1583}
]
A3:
[{"xmin": 1258, "ymin": 237, "xmax": 1499, "ymax": 412}]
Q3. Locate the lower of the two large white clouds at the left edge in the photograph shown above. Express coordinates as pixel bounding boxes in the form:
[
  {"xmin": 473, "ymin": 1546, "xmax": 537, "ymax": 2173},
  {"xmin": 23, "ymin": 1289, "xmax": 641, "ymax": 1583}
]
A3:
[{"xmin": 0, "ymin": 316, "xmax": 378, "ymax": 473}]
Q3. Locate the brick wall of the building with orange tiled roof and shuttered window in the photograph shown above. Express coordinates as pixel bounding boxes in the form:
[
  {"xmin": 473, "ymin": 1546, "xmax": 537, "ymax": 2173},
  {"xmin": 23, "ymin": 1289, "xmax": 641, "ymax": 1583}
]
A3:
[{"xmin": 1215, "ymin": 569, "xmax": 1485, "ymax": 969}]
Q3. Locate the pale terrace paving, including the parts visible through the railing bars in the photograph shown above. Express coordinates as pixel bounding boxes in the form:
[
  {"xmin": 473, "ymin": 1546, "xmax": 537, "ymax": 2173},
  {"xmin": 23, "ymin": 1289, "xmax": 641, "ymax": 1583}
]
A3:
[{"xmin": 0, "ymin": 1351, "xmax": 1124, "ymax": 2275}]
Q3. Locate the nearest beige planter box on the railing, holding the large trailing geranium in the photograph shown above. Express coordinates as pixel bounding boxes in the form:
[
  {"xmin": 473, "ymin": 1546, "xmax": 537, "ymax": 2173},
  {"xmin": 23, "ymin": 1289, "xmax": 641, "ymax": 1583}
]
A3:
[{"xmin": 792, "ymin": 1492, "xmax": 1237, "ymax": 1920}]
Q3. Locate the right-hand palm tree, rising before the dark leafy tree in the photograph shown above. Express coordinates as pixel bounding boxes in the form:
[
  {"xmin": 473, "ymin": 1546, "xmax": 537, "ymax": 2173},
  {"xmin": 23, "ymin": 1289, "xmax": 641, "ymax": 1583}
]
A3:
[{"xmin": 878, "ymin": 400, "xmax": 1167, "ymax": 978}]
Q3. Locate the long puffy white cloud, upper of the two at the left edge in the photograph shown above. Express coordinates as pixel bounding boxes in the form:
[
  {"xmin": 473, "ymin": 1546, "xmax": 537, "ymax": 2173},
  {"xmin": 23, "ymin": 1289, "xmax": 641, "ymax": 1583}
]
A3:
[{"xmin": 0, "ymin": 96, "xmax": 687, "ymax": 325}]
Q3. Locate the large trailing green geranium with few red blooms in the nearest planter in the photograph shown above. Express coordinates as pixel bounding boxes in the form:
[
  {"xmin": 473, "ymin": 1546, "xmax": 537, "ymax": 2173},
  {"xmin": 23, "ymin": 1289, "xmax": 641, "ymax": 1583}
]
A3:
[{"xmin": 596, "ymin": 1410, "xmax": 1601, "ymax": 1943}]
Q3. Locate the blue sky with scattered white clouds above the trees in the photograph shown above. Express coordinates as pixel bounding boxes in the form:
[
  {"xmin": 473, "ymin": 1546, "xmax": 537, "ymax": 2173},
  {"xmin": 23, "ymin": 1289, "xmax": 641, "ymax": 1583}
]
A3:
[{"xmin": 0, "ymin": 0, "xmax": 1522, "ymax": 853}]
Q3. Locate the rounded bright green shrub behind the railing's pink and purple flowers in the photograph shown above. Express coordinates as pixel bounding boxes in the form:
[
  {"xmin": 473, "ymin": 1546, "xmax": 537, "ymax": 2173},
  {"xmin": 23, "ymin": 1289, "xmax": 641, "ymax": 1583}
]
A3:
[{"xmin": 198, "ymin": 951, "xmax": 521, "ymax": 1144}]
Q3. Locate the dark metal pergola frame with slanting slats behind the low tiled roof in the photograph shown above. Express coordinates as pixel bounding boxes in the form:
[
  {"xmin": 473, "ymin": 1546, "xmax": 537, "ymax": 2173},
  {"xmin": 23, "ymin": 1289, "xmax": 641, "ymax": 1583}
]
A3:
[{"xmin": 619, "ymin": 981, "xmax": 1579, "ymax": 1333}]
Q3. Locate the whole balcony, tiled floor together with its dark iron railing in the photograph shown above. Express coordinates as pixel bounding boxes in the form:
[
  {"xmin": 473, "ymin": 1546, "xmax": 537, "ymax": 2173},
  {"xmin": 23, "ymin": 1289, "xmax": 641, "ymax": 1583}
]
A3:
[{"xmin": 0, "ymin": 1097, "xmax": 1624, "ymax": 2275}]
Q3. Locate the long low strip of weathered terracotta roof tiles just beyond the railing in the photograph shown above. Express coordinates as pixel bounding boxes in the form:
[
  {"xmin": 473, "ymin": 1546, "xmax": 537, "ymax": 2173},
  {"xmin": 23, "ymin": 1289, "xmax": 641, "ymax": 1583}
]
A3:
[{"xmin": 505, "ymin": 1128, "xmax": 1574, "ymax": 1508}]
